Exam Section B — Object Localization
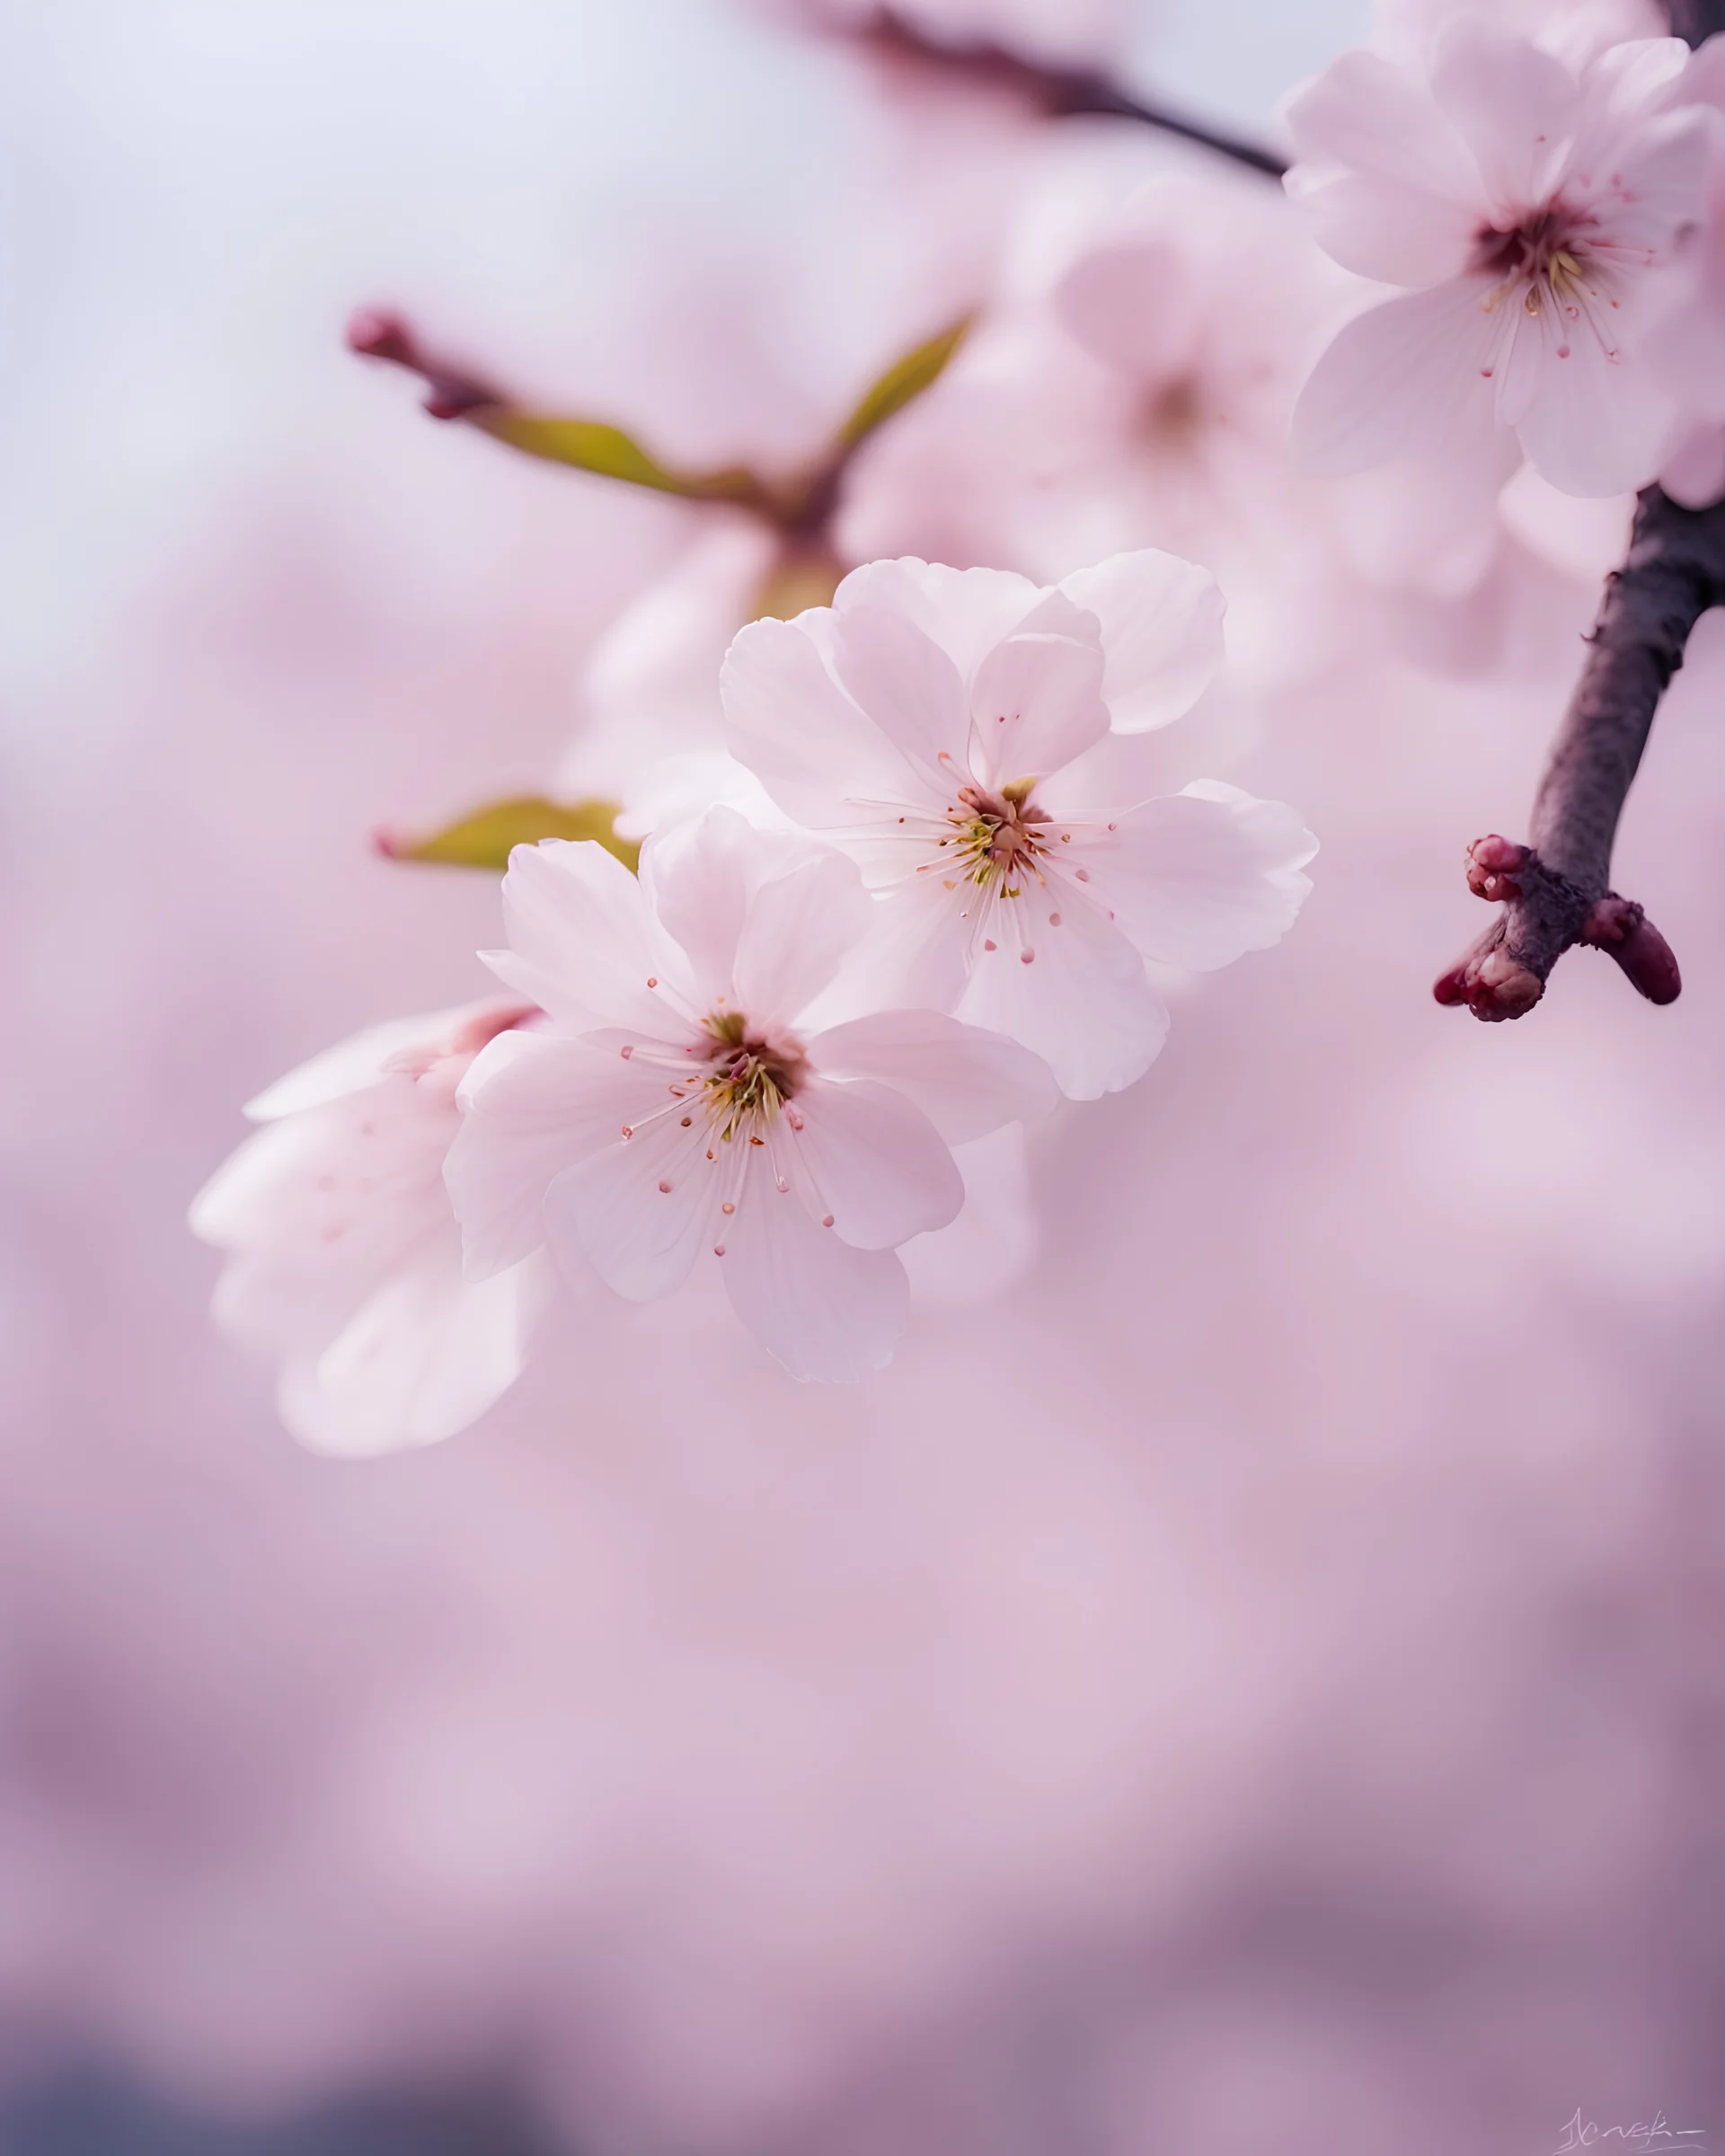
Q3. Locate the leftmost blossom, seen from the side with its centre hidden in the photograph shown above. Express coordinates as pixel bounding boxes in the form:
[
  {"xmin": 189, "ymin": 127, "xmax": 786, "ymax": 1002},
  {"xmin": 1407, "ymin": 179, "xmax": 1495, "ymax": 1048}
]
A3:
[{"xmin": 192, "ymin": 1003, "xmax": 550, "ymax": 1455}]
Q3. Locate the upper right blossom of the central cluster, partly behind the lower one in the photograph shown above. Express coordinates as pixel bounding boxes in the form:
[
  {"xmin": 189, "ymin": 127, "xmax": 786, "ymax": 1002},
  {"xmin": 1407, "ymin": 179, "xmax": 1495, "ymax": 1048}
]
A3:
[{"xmin": 724, "ymin": 552, "xmax": 1315, "ymax": 1100}]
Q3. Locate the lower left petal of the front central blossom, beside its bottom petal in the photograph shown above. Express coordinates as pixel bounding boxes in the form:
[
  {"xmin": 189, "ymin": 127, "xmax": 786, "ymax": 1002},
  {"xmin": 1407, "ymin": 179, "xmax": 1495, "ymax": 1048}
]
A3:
[{"xmin": 545, "ymin": 1109, "xmax": 720, "ymax": 1303}]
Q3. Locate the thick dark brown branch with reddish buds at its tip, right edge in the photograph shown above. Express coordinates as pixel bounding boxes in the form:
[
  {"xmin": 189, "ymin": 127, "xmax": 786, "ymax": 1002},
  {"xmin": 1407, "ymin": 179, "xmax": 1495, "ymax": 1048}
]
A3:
[{"xmin": 1434, "ymin": 487, "xmax": 1725, "ymax": 1018}]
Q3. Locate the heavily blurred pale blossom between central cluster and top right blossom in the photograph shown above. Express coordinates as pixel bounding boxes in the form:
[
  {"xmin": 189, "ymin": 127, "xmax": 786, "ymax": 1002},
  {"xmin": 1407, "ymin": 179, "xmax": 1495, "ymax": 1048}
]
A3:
[{"xmin": 841, "ymin": 154, "xmax": 1358, "ymax": 688}]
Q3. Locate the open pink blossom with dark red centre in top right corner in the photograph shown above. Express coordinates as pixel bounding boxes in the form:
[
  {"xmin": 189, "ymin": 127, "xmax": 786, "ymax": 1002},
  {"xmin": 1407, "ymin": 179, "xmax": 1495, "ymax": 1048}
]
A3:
[{"xmin": 1287, "ymin": 15, "xmax": 1708, "ymax": 494}]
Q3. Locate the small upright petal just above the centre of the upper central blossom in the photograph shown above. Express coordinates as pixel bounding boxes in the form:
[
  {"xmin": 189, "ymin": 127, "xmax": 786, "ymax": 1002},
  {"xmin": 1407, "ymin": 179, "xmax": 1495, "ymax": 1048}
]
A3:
[{"xmin": 970, "ymin": 593, "xmax": 1109, "ymax": 785}]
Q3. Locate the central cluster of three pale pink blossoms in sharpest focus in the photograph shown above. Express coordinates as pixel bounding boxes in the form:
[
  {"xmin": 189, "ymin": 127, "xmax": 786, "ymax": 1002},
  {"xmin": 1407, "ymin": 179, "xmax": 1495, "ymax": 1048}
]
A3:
[{"xmin": 194, "ymin": 550, "xmax": 1314, "ymax": 1414}]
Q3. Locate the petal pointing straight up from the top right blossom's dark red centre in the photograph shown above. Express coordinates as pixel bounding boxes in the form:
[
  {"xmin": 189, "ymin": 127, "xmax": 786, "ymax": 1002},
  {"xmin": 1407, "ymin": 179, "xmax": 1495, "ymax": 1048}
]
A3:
[{"xmin": 1429, "ymin": 15, "xmax": 1580, "ymax": 216}]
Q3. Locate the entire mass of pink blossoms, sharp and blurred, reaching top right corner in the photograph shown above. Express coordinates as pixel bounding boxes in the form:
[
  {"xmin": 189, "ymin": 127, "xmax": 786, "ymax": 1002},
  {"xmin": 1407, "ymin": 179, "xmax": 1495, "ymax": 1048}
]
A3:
[{"xmin": 194, "ymin": 0, "xmax": 1725, "ymax": 1451}]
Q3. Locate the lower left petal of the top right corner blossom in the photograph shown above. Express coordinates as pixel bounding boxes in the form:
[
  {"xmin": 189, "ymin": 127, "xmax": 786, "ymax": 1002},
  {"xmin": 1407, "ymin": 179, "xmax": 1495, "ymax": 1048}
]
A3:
[{"xmin": 1294, "ymin": 276, "xmax": 1505, "ymax": 474}]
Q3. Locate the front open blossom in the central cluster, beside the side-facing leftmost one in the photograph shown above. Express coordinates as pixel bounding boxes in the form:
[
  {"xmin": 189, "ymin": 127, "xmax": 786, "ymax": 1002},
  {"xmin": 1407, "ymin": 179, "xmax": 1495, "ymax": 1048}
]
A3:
[{"xmin": 448, "ymin": 808, "xmax": 1055, "ymax": 1380}]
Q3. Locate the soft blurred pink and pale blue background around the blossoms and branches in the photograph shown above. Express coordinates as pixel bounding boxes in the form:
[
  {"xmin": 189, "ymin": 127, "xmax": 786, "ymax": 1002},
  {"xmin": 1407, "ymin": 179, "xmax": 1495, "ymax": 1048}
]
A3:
[{"xmin": 0, "ymin": 0, "xmax": 1725, "ymax": 2156}]
